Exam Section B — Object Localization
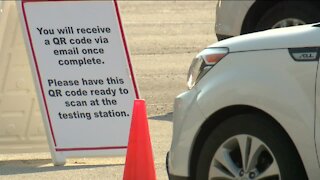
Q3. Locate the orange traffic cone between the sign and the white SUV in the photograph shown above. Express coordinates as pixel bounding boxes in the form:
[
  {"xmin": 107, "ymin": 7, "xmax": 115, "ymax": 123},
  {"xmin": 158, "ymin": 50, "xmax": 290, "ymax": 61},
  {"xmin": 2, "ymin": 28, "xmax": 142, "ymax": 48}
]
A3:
[{"xmin": 123, "ymin": 99, "xmax": 156, "ymax": 180}]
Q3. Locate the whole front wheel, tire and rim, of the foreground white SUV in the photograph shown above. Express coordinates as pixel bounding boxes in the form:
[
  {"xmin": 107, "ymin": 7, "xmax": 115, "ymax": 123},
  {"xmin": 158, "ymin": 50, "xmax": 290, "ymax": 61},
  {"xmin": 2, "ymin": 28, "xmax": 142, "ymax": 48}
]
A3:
[{"xmin": 196, "ymin": 114, "xmax": 307, "ymax": 180}]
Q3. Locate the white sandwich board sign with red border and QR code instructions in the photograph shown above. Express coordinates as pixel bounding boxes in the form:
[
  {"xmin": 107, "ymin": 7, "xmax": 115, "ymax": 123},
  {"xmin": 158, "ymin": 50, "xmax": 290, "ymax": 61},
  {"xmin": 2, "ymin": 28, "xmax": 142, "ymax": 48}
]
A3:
[{"xmin": 19, "ymin": 0, "xmax": 138, "ymax": 165}]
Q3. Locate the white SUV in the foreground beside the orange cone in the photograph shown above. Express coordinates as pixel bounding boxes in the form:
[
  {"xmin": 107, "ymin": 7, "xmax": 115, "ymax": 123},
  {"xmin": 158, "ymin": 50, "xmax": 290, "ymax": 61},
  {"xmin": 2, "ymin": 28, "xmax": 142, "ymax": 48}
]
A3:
[{"xmin": 167, "ymin": 24, "xmax": 320, "ymax": 180}]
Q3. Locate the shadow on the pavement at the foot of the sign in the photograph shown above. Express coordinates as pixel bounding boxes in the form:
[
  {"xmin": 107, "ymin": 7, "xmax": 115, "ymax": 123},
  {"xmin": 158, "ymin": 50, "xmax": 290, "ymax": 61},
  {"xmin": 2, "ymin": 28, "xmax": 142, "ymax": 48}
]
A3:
[{"xmin": 0, "ymin": 159, "xmax": 124, "ymax": 175}]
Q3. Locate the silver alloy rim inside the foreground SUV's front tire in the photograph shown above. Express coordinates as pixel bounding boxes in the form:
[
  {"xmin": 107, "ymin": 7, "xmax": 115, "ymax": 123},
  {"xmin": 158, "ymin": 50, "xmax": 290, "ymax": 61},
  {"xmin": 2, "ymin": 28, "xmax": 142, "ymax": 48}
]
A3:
[{"xmin": 208, "ymin": 135, "xmax": 281, "ymax": 180}]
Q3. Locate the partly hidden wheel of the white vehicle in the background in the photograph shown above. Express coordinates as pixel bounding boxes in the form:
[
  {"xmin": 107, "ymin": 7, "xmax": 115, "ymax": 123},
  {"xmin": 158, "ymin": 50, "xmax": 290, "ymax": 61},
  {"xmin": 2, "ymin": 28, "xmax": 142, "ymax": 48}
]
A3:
[{"xmin": 255, "ymin": 1, "xmax": 320, "ymax": 31}]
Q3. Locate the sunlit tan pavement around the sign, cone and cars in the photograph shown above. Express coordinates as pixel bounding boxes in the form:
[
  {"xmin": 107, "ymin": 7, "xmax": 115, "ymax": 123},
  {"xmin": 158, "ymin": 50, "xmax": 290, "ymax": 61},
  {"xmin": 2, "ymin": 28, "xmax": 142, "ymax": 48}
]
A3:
[{"xmin": 0, "ymin": 1, "xmax": 216, "ymax": 180}]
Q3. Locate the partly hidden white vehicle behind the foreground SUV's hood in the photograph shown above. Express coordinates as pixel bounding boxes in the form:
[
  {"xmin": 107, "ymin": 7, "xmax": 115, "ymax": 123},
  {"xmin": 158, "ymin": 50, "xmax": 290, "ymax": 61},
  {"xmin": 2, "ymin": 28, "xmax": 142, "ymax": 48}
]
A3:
[{"xmin": 215, "ymin": 0, "xmax": 320, "ymax": 40}]
